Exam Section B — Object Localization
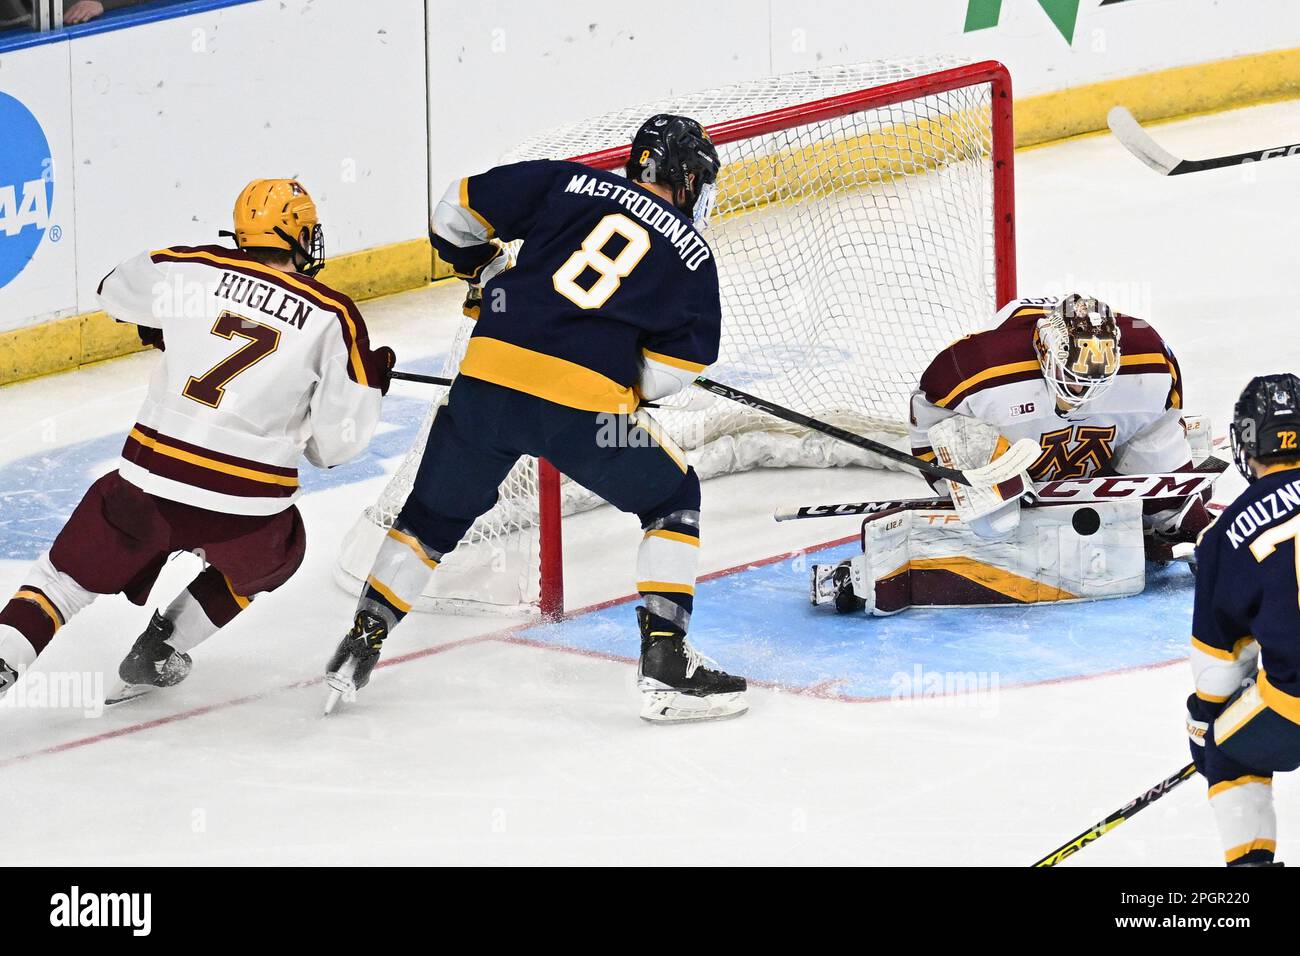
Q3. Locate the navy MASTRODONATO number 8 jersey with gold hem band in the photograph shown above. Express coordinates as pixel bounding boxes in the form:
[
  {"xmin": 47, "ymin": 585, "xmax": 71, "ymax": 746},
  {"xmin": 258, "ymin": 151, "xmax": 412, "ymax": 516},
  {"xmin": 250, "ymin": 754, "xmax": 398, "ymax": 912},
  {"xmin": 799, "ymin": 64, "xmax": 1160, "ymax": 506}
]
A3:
[{"xmin": 444, "ymin": 160, "xmax": 722, "ymax": 412}]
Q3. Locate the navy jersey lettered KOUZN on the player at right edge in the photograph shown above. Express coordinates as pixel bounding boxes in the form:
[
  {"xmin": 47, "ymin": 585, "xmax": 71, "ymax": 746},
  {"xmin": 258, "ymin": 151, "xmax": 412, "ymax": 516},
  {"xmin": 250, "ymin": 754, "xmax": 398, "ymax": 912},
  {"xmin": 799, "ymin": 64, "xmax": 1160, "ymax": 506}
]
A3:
[{"xmin": 1192, "ymin": 468, "xmax": 1300, "ymax": 723}]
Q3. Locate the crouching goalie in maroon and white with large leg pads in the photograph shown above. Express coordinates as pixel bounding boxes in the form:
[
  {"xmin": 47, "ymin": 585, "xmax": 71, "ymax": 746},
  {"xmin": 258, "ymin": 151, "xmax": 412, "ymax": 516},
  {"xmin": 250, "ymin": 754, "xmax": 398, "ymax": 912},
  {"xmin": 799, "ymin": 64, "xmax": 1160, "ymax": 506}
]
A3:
[{"xmin": 811, "ymin": 294, "xmax": 1210, "ymax": 615}]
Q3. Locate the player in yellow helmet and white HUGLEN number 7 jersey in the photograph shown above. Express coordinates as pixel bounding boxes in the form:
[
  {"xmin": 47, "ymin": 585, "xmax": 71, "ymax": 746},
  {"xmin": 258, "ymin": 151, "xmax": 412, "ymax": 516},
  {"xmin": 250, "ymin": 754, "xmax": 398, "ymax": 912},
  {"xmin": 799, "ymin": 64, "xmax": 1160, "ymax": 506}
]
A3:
[{"xmin": 0, "ymin": 179, "xmax": 394, "ymax": 696}]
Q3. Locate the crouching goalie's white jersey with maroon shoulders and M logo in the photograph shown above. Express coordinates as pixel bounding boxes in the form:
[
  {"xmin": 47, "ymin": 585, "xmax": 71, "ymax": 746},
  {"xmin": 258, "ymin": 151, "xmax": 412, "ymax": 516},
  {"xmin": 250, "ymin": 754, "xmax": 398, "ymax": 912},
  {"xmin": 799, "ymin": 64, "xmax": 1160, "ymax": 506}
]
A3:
[{"xmin": 910, "ymin": 298, "xmax": 1192, "ymax": 481}]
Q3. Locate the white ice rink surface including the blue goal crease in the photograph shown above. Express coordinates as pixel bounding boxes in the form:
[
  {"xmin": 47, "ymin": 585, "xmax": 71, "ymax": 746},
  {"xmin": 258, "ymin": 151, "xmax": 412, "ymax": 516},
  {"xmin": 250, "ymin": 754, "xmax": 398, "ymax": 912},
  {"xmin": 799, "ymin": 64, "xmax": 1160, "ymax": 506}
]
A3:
[{"xmin": 0, "ymin": 103, "xmax": 1300, "ymax": 865}]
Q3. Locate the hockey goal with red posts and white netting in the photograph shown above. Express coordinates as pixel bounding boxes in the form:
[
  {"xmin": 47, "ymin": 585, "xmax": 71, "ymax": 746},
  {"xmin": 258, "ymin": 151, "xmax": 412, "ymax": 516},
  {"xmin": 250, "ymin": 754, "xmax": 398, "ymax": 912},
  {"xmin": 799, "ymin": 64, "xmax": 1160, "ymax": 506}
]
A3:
[{"xmin": 338, "ymin": 57, "xmax": 1015, "ymax": 614}]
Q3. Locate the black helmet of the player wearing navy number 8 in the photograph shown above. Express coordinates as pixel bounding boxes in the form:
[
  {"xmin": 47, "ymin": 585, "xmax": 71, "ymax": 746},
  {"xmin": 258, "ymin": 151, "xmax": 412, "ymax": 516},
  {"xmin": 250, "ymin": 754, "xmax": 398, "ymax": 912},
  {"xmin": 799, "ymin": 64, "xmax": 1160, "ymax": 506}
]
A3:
[{"xmin": 625, "ymin": 113, "xmax": 722, "ymax": 228}]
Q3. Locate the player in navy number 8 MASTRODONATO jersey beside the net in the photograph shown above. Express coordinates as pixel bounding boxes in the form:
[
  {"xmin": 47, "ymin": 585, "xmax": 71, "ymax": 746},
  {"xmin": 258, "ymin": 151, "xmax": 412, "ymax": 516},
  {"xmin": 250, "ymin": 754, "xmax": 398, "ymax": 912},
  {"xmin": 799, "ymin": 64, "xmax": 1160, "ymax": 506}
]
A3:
[{"xmin": 326, "ymin": 114, "xmax": 746, "ymax": 721}]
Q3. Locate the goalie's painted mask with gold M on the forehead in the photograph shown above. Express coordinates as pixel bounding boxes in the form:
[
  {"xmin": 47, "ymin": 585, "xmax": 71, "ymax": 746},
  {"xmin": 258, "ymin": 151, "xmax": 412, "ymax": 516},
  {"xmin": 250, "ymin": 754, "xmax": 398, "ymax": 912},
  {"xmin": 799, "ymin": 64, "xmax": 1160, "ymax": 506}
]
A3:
[{"xmin": 1034, "ymin": 294, "xmax": 1119, "ymax": 411}]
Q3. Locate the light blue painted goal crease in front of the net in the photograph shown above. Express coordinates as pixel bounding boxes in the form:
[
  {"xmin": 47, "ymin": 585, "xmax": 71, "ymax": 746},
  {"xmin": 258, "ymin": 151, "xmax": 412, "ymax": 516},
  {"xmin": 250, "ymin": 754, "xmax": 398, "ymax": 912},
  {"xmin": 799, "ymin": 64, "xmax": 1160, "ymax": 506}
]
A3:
[{"xmin": 516, "ymin": 544, "xmax": 1193, "ymax": 706}]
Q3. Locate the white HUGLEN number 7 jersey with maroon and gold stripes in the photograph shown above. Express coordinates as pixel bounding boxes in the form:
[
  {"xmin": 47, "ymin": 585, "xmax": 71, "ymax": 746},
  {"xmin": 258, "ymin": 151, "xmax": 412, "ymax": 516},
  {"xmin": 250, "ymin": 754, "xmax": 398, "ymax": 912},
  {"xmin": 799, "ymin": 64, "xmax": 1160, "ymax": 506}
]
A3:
[{"xmin": 99, "ymin": 246, "xmax": 381, "ymax": 515}]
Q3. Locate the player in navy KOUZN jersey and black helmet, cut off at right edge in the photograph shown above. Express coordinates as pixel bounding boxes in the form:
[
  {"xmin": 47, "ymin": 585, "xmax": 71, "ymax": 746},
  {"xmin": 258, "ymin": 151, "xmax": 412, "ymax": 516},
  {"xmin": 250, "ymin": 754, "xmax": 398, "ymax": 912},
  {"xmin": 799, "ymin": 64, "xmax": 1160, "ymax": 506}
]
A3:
[{"xmin": 1187, "ymin": 375, "xmax": 1300, "ymax": 866}]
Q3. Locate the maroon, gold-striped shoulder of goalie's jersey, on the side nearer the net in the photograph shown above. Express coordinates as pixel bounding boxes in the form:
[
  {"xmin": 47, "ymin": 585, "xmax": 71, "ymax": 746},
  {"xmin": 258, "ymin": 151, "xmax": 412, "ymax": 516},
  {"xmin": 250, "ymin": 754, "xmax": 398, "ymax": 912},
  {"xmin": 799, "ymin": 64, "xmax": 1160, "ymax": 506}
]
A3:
[{"xmin": 920, "ymin": 303, "xmax": 1044, "ymax": 408}]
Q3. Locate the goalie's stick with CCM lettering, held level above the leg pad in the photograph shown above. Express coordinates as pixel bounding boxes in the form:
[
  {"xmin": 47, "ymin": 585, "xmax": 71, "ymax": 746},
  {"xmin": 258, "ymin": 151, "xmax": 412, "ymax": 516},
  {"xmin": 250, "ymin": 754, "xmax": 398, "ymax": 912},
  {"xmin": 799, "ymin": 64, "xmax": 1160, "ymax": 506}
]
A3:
[{"xmin": 772, "ymin": 471, "xmax": 1218, "ymax": 522}]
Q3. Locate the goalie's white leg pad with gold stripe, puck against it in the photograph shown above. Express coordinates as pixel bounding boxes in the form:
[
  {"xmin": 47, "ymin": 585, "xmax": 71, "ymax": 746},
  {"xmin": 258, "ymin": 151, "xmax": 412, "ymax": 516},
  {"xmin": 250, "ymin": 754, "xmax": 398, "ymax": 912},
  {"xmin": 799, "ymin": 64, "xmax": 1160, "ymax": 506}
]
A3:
[{"xmin": 852, "ymin": 501, "xmax": 1145, "ymax": 615}]
